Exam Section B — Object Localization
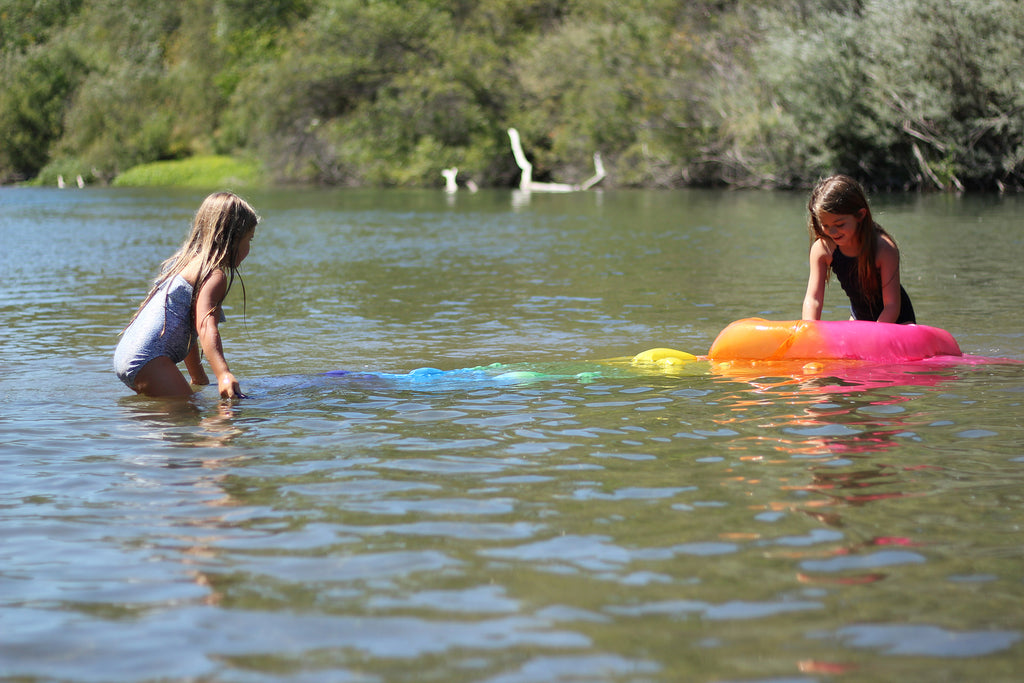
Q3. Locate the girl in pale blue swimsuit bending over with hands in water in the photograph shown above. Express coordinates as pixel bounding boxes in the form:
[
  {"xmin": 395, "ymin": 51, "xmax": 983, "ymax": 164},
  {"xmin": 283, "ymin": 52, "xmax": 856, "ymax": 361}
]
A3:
[{"xmin": 114, "ymin": 193, "xmax": 259, "ymax": 398}]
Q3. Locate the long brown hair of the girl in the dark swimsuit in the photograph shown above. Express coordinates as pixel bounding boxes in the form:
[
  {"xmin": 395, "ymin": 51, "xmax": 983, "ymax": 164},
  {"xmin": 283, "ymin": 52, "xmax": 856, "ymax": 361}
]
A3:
[{"xmin": 807, "ymin": 175, "xmax": 895, "ymax": 297}]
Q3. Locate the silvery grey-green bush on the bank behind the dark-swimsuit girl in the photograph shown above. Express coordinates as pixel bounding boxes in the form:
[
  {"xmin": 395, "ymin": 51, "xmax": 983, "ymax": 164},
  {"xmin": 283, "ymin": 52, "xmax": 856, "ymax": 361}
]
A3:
[{"xmin": 719, "ymin": 0, "xmax": 1024, "ymax": 189}]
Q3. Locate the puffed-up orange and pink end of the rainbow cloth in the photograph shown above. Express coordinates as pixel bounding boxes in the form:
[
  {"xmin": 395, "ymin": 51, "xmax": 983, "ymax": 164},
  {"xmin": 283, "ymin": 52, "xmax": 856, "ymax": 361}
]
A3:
[{"xmin": 708, "ymin": 317, "xmax": 963, "ymax": 362}]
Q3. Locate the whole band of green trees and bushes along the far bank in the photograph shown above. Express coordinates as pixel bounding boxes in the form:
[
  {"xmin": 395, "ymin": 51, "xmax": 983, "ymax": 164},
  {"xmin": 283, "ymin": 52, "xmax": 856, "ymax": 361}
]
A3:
[{"xmin": 0, "ymin": 0, "xmax": 1024, "ymax": 189}]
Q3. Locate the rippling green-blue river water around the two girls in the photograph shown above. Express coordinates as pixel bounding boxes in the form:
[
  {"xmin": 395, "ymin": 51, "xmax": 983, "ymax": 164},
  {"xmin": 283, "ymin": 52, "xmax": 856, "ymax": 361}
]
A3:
[{"xmin": 0, "ymin": 188, "xmax": 1024, "ymax": 683}]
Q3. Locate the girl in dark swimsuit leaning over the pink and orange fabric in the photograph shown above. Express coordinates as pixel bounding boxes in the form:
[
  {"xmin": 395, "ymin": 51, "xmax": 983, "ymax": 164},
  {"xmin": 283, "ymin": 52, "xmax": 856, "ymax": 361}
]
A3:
[{"xmin": 803, "ymin": 175, "xmax": 916, "ymax": 324}]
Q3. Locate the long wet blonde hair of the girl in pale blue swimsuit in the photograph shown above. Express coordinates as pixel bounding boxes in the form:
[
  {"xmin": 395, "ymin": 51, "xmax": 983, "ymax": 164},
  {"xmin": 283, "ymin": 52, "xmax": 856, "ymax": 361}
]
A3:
[{"xmin": 128, "ymin": 193, "xmax": 260, "ymax": 325}]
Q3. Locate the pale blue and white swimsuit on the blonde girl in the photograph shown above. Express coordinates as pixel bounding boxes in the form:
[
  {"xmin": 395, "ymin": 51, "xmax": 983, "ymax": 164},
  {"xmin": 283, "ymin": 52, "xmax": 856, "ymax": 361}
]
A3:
[{"xmin": 114, "ymin": 275, "xmax": 199, "ymax": 390}]
